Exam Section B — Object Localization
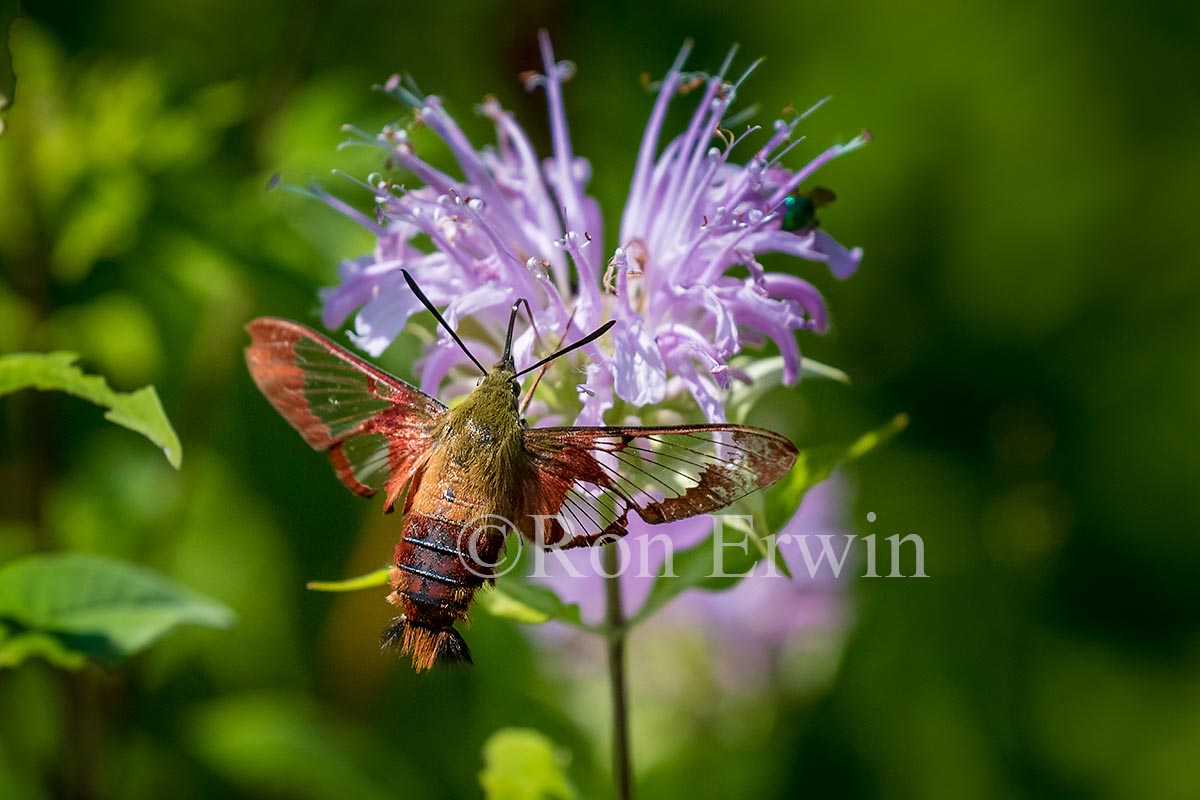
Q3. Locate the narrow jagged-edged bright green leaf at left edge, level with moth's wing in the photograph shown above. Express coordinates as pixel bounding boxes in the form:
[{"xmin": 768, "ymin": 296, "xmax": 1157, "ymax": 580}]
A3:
[{"xmin": 0, "ymin": 353, "xmax": 184, "ymax": 469}]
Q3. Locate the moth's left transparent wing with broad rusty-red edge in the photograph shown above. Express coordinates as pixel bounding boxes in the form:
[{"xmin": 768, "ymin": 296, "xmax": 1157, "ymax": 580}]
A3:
[{"xmin": 246, "ymin": 318, "xmax": 446, "ymax": 510}]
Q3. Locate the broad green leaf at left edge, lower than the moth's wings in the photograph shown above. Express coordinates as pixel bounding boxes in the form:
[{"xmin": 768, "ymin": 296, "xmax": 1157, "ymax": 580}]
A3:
[{"xmin": 0, "ymin": 553, "xmax": 234, "ymax": 666}]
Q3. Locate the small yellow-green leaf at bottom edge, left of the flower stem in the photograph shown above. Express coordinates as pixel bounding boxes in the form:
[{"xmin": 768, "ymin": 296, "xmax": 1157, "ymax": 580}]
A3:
[{"xmin": 479, "ymin": 728, "xmax": 580, "ymax": 800}]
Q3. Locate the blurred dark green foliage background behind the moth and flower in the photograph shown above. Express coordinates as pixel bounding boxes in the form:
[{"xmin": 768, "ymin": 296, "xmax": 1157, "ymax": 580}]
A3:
[{"xmin": 0, "ymin": 0, "xmax": 1200, "ymax": 798}]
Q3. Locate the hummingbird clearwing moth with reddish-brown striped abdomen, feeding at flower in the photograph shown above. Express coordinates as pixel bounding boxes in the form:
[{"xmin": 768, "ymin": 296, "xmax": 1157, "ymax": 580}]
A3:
[{"xmin": 246, "ymin": 272, "xmax": 797, "ymax": 672}]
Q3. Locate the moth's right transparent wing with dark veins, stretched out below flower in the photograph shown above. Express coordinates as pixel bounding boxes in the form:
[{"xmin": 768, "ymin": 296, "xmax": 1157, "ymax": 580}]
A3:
[{"xmin": 523, "ymin": 425, "xmax": 797, "ymax": 548}]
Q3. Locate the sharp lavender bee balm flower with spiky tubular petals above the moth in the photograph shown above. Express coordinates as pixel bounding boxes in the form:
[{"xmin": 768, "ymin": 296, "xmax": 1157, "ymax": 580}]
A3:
[{"xmin": 323, "ymin": 31, "xmax": 868, "ymax": 425}]
